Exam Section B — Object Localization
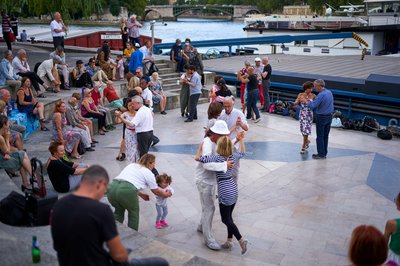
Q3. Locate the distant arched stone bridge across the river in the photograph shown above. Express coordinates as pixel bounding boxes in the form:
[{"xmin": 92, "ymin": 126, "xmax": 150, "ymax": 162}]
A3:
[{"xmin": 144, "ymin": 5, "xmax": 260, "ymax": 20}]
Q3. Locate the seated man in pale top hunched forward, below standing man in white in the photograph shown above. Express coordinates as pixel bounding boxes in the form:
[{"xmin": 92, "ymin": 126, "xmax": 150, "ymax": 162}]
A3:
[{"xmin": 37, "ymin": 56, "xmax": 61, "ymax": 92}]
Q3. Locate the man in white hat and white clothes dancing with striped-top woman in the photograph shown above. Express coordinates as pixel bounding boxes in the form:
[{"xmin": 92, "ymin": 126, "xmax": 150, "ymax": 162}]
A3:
[{"xmin": 195, "ymin": 120, "xmax": 233, "ymax": 250}]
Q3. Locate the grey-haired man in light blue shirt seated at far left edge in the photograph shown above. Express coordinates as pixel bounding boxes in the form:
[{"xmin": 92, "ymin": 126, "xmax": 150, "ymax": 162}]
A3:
[{"xmin": 0, "ymin": 50, "xmax": 21, "ymax": 93}]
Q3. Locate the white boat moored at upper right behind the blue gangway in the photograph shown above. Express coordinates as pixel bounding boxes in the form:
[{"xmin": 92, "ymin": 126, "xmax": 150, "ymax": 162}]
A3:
[{"xmin": 244, "ymin": 0, "xmax": 400, "ymax": 55}]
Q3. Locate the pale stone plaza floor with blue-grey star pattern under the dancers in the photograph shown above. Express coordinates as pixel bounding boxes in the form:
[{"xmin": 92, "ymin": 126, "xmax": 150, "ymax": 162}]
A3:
[{"xmin": 0, "ymin": 98, "xmax": 400, "ymax": 266}]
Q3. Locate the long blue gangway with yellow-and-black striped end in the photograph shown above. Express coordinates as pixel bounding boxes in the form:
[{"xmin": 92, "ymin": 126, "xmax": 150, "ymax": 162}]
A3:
[{"xmin": 153, "ymin": 32, "xmax": 368, "ymax": 55}]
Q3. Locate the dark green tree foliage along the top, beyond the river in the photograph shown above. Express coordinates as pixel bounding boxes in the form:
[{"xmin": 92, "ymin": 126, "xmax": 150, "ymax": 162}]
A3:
[{"xmin": 0, "ymin": 0, "xmax": 363, "ymax": 19}]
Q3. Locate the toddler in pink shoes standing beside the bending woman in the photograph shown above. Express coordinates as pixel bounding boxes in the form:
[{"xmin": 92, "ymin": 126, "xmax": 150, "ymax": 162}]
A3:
[{"xmin": 156, "ymin": 174, "xmax": 174, "ymax": 229}]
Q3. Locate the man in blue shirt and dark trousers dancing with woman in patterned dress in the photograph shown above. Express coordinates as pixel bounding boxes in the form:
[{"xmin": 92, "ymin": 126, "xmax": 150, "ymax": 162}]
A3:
[{"xmin": 308, "ymin": 79, "xmax": 334, "ymax": 159}]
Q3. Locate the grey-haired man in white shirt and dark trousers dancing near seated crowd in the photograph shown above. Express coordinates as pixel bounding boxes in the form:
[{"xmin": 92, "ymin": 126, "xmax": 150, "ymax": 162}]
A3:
[{"xmin": 116, "ymin": 95, "xmax": 153, "ymax": 157}]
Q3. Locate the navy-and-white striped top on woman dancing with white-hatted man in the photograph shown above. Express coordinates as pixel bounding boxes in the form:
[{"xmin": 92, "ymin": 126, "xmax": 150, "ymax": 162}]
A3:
[{"xmin": 200, "ymin": 152, "xmax": 244, "ymax": 206}]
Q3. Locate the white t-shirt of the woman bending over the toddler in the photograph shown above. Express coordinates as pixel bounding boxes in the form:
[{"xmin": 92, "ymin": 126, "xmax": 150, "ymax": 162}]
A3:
[{"xmin": 115, "ymin": 163, "xmax": 158, "ymax": 190}]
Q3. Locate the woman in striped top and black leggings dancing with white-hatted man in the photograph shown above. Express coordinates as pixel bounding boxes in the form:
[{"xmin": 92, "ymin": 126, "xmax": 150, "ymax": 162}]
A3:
[{"xmin": 195, "ymin": 136, "xmax": 248, "ymax": 255}]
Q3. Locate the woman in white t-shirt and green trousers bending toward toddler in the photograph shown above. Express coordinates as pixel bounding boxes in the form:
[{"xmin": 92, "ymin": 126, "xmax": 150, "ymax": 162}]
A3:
[{"xmin": 107, "ymin": 153, "xmax": 172, "ymax": 231}]
